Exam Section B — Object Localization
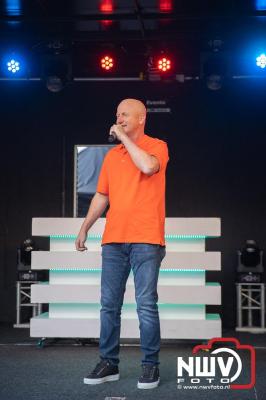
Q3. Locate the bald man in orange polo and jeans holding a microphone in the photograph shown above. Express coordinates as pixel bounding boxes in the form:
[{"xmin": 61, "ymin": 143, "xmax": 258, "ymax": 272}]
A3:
[{"xmin": 76, "ymin": 99, "xmax": 168, "ymax": 389}]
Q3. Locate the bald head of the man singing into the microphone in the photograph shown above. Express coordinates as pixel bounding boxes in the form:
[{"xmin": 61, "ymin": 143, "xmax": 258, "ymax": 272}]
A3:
[{"xmin": 116, "ymin": 99, "xmax": 146, "ymax": 137}]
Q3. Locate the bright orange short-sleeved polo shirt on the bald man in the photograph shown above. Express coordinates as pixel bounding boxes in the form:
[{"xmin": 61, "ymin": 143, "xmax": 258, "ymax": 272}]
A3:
[{"xmin": 97, "ymin": 135, "xmax": 169, "ymax": 245}]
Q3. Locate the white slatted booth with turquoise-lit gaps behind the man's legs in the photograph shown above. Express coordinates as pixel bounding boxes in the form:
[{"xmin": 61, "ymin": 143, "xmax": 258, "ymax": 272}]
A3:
[{"xmin": 30, "ymin": 218, "xmax": 221, "ymax": 339}]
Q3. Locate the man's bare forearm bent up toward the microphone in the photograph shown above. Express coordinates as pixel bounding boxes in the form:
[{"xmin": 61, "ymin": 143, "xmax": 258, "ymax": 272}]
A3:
[{"xmin": 122, "ymin": 135, "xmax": 159, "ymax": 175}]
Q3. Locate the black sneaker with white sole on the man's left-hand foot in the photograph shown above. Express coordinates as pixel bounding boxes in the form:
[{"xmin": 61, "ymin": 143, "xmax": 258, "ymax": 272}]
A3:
[{"xmin": 84, "ymin": 360, "xmax": 119, "ymax": 385}]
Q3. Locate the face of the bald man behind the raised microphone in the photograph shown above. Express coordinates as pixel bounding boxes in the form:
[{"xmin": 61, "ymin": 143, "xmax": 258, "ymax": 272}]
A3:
[{"xmin": 116, "ymin": 101, "xmax": 143, "ymax": 135}]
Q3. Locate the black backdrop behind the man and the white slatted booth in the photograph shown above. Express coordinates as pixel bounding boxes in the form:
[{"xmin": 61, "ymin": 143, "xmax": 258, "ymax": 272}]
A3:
[{"xmin": 0, "ymin": 80, "xmax": 266, "ymax": 328}]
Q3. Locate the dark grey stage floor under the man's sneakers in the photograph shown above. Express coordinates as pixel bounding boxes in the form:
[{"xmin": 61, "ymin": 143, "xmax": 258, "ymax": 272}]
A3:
[{"xmin": 0, "ymin": 325, "xmax": 266, "ymax": 400}]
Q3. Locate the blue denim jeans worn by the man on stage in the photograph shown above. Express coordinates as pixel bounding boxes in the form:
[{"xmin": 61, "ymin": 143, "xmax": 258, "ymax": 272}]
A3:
[{"xmin": 99, "ymin": 243, "xmax": 165, "ymax": 365}]
